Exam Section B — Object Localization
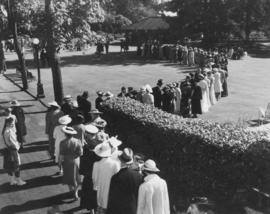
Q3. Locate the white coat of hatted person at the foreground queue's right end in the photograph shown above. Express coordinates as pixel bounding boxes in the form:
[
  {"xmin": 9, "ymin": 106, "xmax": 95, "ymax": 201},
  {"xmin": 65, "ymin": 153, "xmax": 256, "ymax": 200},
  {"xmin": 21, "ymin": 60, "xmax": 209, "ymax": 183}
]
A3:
[{"xmin": 137, "ymin": 174, "xmax": 170, "ymax": 214}]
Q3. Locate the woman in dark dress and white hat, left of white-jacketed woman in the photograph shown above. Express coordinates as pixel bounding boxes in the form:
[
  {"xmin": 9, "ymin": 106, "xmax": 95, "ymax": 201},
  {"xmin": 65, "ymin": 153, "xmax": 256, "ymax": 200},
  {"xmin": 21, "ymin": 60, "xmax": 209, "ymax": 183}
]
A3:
[{"xmin": 79, "ymin": 124, "xmax": 101, "ymax": 213}]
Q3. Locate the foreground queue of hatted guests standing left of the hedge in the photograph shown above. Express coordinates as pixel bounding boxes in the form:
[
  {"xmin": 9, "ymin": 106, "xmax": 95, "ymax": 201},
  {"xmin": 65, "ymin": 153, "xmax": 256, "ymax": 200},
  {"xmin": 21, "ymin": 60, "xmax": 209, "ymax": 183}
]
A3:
[{"xmin": 42, "ymin": 91, "xmax": 170, "ymax": 214}]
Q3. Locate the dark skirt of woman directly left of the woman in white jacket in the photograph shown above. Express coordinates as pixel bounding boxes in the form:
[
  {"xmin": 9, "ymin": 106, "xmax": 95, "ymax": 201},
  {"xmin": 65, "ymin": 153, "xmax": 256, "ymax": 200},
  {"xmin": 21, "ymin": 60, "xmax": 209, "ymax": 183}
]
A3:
[{"xmin": 80, "ymin": 176, "xmax": 97, "ymax": 210}]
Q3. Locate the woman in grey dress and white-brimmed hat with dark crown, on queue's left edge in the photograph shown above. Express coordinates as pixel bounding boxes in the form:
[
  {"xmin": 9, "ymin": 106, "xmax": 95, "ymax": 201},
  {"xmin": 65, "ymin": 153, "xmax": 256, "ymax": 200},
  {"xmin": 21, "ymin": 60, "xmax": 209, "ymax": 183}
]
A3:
[{"xmin": 60, "ymin": 126, "xmax": 83, "ymax": 199}]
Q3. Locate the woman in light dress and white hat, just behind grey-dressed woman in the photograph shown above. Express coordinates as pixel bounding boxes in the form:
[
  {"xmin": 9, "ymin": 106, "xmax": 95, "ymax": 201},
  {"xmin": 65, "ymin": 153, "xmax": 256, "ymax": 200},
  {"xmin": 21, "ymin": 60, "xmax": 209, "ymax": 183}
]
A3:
[{"xmin": 53, "ymin": 115, "xmax": 72, "ymax": 175}]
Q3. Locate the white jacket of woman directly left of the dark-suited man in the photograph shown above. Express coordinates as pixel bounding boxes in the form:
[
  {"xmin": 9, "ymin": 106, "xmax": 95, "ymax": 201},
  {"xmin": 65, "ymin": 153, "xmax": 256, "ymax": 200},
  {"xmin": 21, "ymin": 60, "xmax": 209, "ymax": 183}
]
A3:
[{"xmin": 92, "ymin": 157, "xmax": 120, "ymax": 209}]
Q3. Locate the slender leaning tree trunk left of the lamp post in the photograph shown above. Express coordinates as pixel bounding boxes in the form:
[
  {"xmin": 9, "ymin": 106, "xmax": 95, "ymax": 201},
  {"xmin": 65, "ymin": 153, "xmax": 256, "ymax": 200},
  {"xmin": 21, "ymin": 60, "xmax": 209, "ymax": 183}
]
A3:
[{"xmin": 7, "ymin": 0, "xmax": 28, "ymax": 90}]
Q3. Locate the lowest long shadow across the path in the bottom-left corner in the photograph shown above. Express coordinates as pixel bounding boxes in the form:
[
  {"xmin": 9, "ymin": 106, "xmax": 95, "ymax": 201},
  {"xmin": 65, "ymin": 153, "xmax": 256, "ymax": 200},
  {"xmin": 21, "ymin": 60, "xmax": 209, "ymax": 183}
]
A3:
[{"xmin": 0, "ymin": 193, "xmax": 72, "ymax": 214}]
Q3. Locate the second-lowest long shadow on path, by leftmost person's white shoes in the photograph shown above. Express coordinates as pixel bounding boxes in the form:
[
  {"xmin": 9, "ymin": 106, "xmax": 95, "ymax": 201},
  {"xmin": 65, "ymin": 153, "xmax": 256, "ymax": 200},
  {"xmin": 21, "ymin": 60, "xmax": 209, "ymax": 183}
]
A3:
[{"xmin": 0, "ymin": 176, "xmax": 62, "ymax": 195}]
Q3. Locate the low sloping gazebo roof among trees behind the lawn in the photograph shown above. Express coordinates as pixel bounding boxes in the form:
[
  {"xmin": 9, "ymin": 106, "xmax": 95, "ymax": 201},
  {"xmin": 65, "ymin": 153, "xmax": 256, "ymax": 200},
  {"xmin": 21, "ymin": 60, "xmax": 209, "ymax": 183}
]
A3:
[{"xmin": 124, "ymin": 16, "xmax": 170, "ymax": 30}]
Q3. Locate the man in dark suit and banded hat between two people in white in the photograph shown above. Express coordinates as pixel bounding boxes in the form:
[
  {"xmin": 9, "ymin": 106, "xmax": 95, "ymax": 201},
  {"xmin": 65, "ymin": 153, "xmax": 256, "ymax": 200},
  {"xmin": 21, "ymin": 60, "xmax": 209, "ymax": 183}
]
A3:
[{"xmin": 107, "ymin": 148, "xmax": 143, "ymax": 214}]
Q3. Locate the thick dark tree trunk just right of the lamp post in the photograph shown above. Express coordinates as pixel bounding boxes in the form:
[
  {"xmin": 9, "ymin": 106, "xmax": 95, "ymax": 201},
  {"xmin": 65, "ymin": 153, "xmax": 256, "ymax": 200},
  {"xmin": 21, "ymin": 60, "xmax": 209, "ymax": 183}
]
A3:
[{"xmin": 45, "ymin": 0, "xmax": 63, "ymax": 105}]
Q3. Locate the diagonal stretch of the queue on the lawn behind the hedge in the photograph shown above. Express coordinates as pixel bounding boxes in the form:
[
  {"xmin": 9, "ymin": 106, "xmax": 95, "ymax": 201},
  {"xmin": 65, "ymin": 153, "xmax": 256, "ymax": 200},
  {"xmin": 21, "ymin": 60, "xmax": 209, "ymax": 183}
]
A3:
[{"xmin": 115, "ymin": 46, "xmax": 228, "ymax": 117}]
